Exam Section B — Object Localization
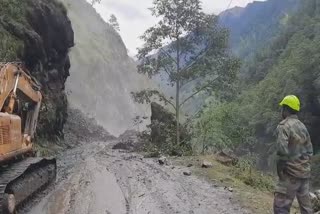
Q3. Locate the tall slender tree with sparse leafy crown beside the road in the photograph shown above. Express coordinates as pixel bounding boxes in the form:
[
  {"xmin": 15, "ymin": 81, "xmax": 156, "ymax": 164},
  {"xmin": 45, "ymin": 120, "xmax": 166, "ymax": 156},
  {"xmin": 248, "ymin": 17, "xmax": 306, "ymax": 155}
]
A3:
[{"xmin": 132, "ymin": 0, "xmax": 239, "ymax": 144}]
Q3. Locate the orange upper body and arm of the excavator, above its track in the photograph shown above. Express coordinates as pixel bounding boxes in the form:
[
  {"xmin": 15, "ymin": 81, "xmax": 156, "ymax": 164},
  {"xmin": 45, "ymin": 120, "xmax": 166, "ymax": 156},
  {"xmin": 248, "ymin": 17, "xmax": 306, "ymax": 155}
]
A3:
[{"xmin": 0, "ymin": 63, "xmax": 42, "ymax": 164}]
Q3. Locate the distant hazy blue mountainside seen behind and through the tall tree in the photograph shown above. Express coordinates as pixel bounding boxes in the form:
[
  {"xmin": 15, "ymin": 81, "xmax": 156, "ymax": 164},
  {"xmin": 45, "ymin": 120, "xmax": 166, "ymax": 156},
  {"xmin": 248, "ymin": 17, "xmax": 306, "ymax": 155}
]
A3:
[{"xmin": 155, "ymin": 0, "xmax": 299, "ymax": 115}]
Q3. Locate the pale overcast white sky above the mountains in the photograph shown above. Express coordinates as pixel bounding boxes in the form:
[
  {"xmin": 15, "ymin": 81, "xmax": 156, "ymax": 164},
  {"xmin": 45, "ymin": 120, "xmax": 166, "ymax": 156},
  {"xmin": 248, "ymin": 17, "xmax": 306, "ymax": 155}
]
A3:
[{"xmin": 88, "ymin": 0, "xmax": 261, "ymax": 56}]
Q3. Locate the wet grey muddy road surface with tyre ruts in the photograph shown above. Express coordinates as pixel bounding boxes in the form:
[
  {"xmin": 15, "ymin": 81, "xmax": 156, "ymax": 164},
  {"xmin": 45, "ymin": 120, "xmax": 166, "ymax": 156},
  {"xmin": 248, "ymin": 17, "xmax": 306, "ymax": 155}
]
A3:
[{"xmin": 19, "ymin": 142, "xmax": 248, "ymax": 214}]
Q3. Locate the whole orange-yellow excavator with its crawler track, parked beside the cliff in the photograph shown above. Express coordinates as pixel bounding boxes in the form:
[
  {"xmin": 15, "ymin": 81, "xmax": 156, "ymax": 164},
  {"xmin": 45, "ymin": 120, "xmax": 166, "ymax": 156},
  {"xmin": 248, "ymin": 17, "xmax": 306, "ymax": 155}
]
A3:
[{"xmin": 0, "ymin": 63, "xmax": 57, "ymax": 214}]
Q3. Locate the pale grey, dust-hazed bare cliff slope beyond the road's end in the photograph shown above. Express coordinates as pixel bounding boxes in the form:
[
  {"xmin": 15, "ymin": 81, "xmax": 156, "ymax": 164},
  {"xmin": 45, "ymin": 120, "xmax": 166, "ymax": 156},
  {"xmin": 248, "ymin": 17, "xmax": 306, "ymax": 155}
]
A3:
[{"xmin": 63, "ymin": 0, "xmax": 148, "ymax": 135}]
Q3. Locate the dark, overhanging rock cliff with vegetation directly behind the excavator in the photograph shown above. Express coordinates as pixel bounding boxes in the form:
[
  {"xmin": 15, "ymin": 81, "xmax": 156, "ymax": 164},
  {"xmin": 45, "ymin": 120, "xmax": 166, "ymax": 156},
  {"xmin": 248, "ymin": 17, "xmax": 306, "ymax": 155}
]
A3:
[{"xmin": 0, "ymin": 0, "xmax": 74, "ymax": 137}]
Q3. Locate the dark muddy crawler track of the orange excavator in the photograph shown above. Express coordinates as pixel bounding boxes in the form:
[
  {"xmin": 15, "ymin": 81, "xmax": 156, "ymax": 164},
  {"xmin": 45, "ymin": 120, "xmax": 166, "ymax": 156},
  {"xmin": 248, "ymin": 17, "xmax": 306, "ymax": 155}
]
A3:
[{"xmin": 0, "ymin": 158, "xmax": 57, "ymax": 214}]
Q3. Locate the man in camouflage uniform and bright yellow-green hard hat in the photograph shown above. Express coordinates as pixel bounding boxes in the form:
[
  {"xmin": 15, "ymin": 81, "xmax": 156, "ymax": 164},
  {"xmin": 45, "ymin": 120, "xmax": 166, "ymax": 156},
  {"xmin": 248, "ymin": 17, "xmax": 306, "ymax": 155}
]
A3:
[{"xmin": 274, "ymin": 95, "xmax": 313, "ymax": 214}]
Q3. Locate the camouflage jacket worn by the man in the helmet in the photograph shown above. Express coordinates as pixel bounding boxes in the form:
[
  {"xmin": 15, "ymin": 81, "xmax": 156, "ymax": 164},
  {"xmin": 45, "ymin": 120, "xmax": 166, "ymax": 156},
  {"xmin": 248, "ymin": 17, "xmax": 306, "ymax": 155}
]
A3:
[{"xmin": 277, "ymin": 115, "xmax": 313, "ymax": 178}]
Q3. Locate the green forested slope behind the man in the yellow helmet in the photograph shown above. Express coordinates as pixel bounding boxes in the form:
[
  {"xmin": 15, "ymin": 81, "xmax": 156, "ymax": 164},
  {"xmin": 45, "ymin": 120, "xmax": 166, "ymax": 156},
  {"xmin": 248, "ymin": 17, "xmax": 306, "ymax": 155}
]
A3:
[{"xmin": 197, "ymin": 0, "xmax": 320, "ymax": 162}]
